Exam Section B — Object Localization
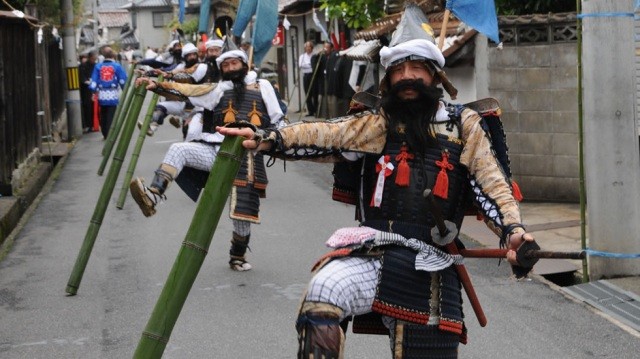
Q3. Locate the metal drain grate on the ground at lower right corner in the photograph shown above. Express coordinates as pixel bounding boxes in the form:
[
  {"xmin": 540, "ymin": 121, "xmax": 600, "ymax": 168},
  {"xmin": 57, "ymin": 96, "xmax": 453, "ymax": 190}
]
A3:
[{"xmin": 562, "ymin": 280, "xmax": 640, "ymax": 331}]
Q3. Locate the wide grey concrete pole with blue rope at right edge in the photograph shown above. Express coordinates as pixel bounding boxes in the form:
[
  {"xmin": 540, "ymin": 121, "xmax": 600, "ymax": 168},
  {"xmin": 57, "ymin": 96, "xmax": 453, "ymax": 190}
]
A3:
[{"xmin": 582, "ymin": 0, "xmax": 640, "ymax": 279}]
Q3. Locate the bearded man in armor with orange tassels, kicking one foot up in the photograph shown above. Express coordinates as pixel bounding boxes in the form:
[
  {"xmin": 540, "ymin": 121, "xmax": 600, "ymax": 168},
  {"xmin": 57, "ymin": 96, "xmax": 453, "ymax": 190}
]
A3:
[{"xmin": 130, "ymin": 43, "xmax": 283, "ymax": 271}]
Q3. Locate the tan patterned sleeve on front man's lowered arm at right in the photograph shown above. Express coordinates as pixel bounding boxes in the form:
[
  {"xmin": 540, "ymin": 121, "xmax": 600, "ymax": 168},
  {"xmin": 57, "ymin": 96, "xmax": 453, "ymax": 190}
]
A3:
[{"xmin": 460, "ymin": 109, "xmax": 522, "ymax": 243}]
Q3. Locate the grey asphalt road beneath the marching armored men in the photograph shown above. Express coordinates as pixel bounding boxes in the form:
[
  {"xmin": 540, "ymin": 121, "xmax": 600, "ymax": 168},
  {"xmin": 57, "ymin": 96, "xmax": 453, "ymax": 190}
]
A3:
[{"xmin": 0, "ymin": 116, "xmax": 640, "ymax": 359}]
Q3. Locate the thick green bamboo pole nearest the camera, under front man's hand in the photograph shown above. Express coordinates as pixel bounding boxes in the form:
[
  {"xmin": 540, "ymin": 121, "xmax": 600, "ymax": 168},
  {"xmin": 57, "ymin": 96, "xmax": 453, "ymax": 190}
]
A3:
[{"xmin": 133, "ymin": 136, "xmax": 244, "ymax": 358}]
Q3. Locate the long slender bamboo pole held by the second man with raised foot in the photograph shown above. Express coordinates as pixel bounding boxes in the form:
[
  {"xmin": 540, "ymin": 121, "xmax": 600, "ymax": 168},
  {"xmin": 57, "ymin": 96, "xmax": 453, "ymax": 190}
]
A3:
[{"xmin": 66, "ymin": 85, "xmax": 147, "ymax": 295}]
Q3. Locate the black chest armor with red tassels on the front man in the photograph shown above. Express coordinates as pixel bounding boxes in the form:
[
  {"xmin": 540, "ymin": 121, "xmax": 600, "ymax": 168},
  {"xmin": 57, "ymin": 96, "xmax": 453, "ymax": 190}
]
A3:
[{"xmin": 360, "ymin": 134, "xmax": 468, "ymax": 243}]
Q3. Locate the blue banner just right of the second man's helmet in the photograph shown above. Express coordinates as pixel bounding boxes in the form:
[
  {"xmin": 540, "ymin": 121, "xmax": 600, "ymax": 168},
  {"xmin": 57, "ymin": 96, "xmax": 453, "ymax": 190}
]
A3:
[{"xmin": 251, "ymin": 0, "xmax": 278, "ymax": 65}]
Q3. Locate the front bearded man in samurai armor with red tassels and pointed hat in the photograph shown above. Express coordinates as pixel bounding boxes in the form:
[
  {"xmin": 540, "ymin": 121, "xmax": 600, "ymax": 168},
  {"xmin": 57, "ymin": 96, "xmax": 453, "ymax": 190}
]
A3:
[{"xmin": 218, "ymin": 4, "xmax": 534, "ymax": 358}]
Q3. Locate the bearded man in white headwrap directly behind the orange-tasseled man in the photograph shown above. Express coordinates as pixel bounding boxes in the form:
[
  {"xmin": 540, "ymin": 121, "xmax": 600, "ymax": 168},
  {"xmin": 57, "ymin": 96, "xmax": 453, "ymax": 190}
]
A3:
[{"xmin": 138, "ymin": 43, "xmax": 209, "ymax": 136}]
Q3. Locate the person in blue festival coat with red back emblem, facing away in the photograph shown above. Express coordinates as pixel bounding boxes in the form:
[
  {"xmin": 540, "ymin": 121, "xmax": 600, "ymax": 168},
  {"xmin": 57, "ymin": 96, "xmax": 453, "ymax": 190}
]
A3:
[{"xmin": 89, "ymin": 46, "xmax": 127, "ymax": 139}]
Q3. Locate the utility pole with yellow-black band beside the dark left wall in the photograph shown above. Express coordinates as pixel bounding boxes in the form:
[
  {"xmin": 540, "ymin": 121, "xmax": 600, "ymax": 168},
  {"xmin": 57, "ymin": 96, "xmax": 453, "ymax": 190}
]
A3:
[{"xmin": 61, "ymin": 0, "xmax": 82, "ymax": 139}]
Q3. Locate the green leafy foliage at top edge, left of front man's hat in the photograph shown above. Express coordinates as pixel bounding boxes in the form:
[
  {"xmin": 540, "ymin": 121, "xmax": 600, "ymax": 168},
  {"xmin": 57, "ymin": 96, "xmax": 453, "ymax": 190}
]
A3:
[{"xmin": 320, "ymin": 0, "xmax": 384, "ymax": 29}]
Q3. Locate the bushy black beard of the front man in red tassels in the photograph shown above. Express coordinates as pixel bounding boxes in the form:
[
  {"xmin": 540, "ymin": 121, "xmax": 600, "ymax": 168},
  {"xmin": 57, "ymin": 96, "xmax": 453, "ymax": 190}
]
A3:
[{"xmin": 381, "ymin": 80, "xmax": 442, "ymax": 152}]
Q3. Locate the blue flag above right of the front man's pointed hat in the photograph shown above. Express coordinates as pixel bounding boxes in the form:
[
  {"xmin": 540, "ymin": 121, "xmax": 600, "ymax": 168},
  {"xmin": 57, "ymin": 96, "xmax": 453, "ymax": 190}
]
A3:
[{"xmin": 446, "ymin": 0, "xmax": 500, "ymax": 44}]
